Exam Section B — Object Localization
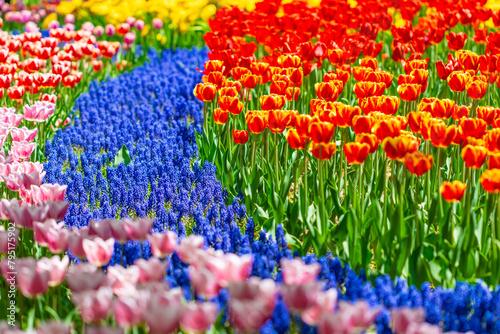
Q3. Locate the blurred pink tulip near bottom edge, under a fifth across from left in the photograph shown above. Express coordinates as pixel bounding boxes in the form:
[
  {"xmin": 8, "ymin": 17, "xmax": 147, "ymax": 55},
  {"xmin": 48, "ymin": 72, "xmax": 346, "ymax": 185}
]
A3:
[{"xmin": 71, "ymin": 287, "xmax": 113, "ymax": 322}]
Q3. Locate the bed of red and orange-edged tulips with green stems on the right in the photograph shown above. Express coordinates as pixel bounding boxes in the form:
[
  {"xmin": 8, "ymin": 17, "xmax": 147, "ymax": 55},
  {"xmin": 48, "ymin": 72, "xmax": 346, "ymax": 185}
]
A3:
[{"xmin": 194, "ymin": 1, "xmax": 500, "ymax": 283}]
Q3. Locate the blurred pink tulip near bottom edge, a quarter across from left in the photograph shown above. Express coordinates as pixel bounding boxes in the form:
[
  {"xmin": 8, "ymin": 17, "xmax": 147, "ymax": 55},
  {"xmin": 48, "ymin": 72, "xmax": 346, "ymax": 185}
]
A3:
[{"xmin": 113, "ymin": 291, "xmax": 149, "ymax": 328}]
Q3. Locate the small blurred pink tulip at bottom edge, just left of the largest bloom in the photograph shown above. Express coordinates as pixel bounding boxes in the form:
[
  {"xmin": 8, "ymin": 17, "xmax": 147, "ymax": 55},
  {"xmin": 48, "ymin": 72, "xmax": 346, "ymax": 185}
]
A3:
[{"xmin": 181, "ymin": 302, "xmax": 218, "ymax": 333}]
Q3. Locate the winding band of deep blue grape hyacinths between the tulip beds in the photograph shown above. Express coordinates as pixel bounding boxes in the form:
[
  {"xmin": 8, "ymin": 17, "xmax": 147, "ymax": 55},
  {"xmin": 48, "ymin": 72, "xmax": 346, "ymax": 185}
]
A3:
[{"xmin": 45, "ymin": 49, "xmax": 500, "ymax": 334}]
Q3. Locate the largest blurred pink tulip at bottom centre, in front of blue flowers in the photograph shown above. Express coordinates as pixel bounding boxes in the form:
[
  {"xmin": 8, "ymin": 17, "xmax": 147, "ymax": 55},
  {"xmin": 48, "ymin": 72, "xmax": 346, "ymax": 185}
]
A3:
[{"xmin": 228, "ymin": 277, "xmax": 278, "ymax": 333}]
